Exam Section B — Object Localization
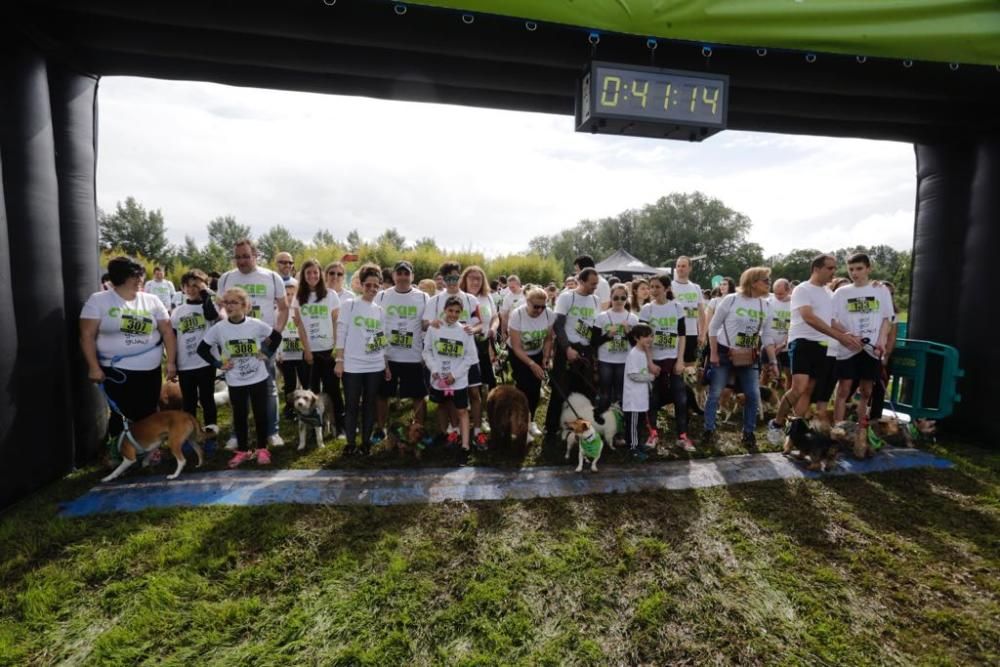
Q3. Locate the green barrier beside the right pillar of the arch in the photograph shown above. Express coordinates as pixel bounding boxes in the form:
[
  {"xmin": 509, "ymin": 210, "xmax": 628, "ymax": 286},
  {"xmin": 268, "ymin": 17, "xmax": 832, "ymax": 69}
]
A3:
[{"xmin": 887, "ymin": 338, "xmax": 965, "ymax": 419}]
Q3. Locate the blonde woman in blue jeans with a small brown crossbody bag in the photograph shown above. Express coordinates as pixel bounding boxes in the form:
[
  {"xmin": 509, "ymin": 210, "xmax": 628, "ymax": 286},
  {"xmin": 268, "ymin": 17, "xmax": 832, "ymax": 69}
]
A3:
[{"xmin": 704, "ymin": 266, "xmax": 778, "ymax": 454}]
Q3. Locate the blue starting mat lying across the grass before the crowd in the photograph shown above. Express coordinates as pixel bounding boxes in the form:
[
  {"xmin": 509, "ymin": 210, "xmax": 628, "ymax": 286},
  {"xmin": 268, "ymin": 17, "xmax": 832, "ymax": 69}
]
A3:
[{"xmin": 61, "ymin": 449, "xmax": 952, "ymax": 517}]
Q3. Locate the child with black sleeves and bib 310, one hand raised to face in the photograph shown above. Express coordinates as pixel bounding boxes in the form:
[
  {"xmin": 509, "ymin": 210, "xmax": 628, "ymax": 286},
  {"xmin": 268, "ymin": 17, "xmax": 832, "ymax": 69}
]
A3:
[{"xmin": 170, "ymin": 269, "xmax": 219, "ymax": 435}]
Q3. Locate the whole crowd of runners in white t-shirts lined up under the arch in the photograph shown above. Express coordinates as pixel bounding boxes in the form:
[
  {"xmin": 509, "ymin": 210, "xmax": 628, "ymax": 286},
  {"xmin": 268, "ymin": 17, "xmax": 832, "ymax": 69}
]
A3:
[{"xmin": 81, "ymin": 240, "xmax": 894, "ymax": 467}]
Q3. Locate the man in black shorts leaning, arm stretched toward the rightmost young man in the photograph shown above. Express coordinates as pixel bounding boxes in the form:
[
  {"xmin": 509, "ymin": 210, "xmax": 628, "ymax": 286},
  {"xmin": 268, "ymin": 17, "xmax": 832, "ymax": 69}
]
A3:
[{"xmin": 767, "ymin": 255, "xmax": 861, "ymax": 445}]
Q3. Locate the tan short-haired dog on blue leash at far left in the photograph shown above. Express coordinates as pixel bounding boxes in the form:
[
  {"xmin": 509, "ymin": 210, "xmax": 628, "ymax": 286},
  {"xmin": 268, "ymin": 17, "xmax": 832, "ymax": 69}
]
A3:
[{"xmin": 101, "ymin": 410, "xmax": 205, "ymax": 482}]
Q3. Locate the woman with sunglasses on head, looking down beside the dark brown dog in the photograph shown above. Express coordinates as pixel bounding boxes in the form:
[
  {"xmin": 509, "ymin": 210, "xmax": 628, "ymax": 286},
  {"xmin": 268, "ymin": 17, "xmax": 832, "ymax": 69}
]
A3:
[{"xmin": 507, "ymin": 287, "xmax": 556, "ymax": 438}]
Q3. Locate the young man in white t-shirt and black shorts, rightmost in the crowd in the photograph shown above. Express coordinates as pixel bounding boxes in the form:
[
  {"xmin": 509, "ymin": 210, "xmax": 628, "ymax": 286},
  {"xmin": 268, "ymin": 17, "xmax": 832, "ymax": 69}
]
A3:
[{"xmin": 833, "ymin": 253, "xmax": 894, "ymax": 424}]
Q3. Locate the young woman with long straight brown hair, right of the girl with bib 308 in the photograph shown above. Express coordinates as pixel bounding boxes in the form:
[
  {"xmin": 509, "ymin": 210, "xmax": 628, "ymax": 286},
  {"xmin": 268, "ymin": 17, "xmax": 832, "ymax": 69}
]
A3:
[{"xmin": 286, "ymin": 259, "xmax": 344, "ymax": 428}]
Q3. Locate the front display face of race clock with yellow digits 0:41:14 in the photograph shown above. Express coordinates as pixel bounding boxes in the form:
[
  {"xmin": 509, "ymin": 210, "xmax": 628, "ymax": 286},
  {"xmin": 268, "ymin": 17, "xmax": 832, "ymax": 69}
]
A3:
[{"xmin": 597, "ymin": 70, "xmax": 723, "ymax": 123}]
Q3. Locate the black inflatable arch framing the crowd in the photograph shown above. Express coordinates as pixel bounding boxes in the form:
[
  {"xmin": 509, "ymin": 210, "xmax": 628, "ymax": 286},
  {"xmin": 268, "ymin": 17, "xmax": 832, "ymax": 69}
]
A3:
[{"xmin": 0, "ymin": 0, "xmax": 1000, "ymax": 507}]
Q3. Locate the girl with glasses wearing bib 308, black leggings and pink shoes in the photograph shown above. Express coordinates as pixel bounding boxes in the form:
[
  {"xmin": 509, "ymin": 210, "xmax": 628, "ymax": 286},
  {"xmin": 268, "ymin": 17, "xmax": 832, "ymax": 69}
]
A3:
[{"xmin": 198, "ymin": 287, "xmax": 281, "ymax": 468}]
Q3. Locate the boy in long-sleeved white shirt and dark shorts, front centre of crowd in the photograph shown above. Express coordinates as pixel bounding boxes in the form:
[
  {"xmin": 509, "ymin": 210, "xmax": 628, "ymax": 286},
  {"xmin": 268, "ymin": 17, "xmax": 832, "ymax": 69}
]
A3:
[{"xmin": 423, "ymin": 296, "xmax": 479, "ymax": 458}]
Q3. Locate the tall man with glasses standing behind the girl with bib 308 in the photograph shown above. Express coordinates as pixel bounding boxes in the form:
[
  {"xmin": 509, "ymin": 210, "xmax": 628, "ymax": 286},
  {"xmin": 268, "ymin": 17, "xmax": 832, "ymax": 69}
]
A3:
[{"xmin": 217, "ymin": 239, "xmax": 288, "ymax": 449}]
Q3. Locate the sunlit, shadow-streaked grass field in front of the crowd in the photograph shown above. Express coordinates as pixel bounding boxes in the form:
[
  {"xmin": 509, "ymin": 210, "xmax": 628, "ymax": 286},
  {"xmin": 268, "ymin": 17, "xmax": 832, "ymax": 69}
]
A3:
[{"xmin": 0, "ymin": 394, "xmax": 1000, "ymax": 665}]
